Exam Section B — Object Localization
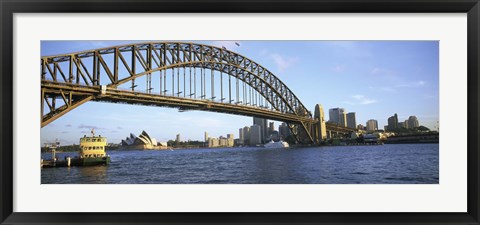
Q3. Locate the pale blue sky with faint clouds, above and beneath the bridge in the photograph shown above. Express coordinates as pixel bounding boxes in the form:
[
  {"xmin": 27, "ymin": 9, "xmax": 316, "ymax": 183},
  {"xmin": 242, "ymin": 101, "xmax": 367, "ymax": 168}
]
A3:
[{"xmin": 41, "ymin": 41, "xmax": 439, "ymax": 144}]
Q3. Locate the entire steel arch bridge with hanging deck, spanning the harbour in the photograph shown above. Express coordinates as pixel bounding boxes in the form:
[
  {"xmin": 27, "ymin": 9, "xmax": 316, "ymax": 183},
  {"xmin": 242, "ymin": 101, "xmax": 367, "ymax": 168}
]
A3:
[{"xmin": 41, "ymin": 42, "xmax": 315, "ymax": 143}]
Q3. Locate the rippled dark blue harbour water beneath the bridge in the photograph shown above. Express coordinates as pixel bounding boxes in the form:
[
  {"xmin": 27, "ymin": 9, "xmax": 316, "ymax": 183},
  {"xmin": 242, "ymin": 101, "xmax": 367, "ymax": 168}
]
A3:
[{"xmin": 41, "ymin": 144, "xmax": 439, "ymax": 184}]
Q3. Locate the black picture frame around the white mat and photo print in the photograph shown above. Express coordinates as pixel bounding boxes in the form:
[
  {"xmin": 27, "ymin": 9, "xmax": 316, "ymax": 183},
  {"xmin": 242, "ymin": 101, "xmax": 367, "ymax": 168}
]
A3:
[{"xmin": 0, "ymin": 0, "xmax": 480, "ymax": 225}]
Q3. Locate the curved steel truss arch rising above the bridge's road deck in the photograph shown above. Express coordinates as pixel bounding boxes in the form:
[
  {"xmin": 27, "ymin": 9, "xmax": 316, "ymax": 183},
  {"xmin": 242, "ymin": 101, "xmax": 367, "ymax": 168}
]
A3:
[{"xmin": 41, "ymin": 42, "xmax": 313, "ymax": 141}]
